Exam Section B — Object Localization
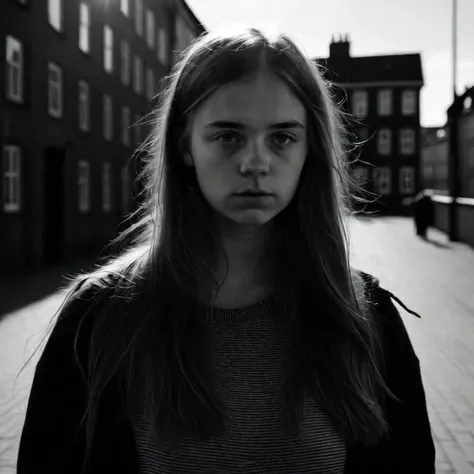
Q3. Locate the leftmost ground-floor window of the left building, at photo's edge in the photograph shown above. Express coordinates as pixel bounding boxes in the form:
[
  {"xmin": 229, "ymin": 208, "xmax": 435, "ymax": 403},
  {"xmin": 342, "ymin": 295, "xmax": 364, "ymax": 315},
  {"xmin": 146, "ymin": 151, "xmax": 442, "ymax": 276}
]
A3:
[{"xmin": 3, "ymin": 145, "xmax": 21, "ymax": 213}]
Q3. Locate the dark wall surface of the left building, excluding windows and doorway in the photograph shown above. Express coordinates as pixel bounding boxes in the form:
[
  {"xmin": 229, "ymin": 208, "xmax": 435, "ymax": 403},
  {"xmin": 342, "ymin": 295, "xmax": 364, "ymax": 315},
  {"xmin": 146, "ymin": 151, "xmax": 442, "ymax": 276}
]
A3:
[{"xmin": 0, "ymin": 0, "xmax": 201, "ymax": 273}]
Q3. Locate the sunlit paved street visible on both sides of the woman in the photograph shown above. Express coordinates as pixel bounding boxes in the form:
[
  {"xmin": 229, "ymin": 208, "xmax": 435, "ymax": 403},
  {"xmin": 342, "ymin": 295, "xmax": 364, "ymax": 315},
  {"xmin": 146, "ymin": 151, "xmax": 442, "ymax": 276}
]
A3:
[{"xmin": 0, "ymin": 217, "xmax": 474, "ymax": 474}]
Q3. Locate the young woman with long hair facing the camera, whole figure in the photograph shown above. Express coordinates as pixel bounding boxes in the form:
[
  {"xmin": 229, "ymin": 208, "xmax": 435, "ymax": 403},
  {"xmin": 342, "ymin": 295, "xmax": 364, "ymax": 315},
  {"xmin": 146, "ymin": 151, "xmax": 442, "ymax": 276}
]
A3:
[{"xmin": 17, "ymin": 30, "xmax": 435, "ymax": 474}]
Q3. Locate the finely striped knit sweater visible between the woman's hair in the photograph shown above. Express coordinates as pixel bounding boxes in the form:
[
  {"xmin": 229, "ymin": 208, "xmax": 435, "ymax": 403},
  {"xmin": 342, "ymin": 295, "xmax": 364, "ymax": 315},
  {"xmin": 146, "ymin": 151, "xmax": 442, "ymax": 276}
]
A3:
[{"xmin": 135, "ymin": 298, "xmax": 346, "ymax": 474}]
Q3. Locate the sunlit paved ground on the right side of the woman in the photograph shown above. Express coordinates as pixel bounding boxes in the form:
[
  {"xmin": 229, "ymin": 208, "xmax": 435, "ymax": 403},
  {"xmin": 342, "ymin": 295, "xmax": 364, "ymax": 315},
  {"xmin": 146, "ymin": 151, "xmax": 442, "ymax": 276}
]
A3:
[{"xmin": 352, "ymin": 218, "xmax": 474, "ymax": 474}]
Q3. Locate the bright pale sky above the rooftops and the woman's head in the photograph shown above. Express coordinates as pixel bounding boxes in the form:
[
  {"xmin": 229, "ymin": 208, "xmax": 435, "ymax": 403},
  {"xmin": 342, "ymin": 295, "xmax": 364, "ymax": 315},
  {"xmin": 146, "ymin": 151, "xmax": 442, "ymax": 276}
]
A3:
[{"xmin": 187, "ymin": 0, "xmax": 474, "ymax": 127}]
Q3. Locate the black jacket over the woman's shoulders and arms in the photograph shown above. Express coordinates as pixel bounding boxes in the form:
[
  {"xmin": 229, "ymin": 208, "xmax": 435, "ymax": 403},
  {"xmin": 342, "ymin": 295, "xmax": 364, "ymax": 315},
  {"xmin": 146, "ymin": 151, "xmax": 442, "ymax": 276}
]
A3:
[{"xmin": 17, "ymin": 276, "xmax": 435, "ymax": 474}]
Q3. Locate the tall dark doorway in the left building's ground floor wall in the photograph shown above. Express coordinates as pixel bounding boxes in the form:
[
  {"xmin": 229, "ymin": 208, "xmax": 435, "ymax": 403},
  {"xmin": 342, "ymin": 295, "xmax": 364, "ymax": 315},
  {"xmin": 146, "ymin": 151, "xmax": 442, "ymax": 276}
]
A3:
[{"xmin": 43, "ymin": 148, "xmax": 66, "ymax": 264}]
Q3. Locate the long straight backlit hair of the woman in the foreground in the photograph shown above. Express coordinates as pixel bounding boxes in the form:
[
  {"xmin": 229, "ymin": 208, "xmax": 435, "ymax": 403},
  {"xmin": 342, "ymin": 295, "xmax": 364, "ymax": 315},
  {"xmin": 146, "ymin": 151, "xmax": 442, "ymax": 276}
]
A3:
[{"xmin": 44, "ymin": 25, "xmax": 390, "ymax": 466}]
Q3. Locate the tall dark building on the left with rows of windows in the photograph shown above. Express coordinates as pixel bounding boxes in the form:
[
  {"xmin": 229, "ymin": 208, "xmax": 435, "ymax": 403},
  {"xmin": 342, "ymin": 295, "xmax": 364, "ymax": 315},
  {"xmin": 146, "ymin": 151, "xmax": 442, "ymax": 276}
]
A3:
[{"xmin": 0, "ymin": 0, "xmax": 203, "ymax": 274}]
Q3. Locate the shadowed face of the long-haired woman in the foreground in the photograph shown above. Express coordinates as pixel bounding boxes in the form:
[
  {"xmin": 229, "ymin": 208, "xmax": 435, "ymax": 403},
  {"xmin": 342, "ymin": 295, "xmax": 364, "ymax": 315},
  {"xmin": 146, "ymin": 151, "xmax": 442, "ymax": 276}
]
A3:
[{"xmin": 185, "ymin": 72, "xmax": 308, "ymax": 225}]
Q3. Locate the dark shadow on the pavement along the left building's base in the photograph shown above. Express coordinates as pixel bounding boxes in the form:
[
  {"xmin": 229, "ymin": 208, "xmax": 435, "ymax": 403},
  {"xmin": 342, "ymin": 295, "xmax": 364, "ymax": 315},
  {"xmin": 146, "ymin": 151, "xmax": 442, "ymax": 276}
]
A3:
[{"xmin": 0, "ymin": 261, "xmax": 93, "ymax": 319}]
